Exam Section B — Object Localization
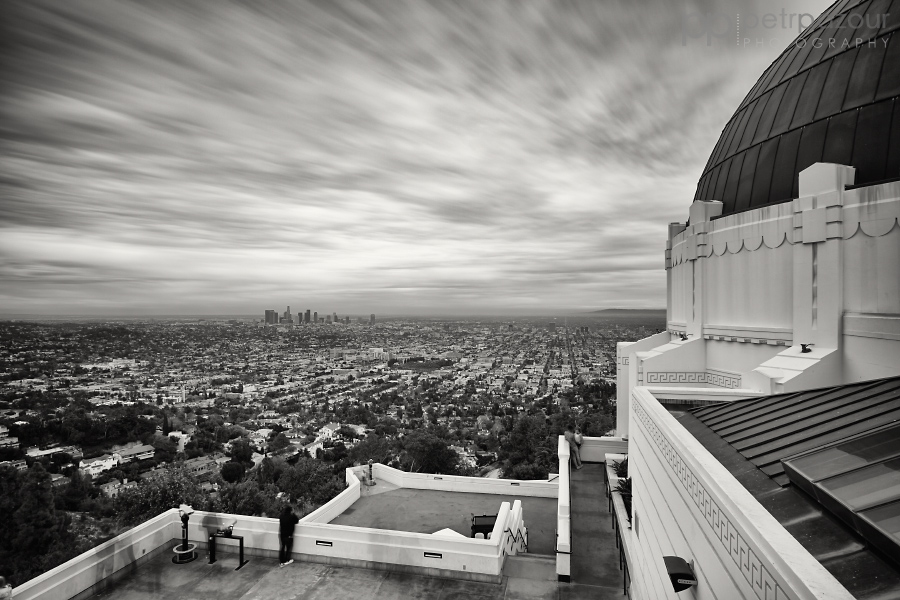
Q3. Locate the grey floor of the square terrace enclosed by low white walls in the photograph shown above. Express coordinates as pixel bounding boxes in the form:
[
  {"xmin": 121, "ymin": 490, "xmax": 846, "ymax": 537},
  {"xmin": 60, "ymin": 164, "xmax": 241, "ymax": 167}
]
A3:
[{"xmin": 331, "ymin": 486, "xmax": 560, "ymax": 554}]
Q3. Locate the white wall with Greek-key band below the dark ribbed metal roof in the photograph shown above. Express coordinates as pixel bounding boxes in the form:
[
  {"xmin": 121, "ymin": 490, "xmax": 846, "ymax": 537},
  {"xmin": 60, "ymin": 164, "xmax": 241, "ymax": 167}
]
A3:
[{"xmin": 628, "ymin": 387, "xmax": 852, "ymax": 600}]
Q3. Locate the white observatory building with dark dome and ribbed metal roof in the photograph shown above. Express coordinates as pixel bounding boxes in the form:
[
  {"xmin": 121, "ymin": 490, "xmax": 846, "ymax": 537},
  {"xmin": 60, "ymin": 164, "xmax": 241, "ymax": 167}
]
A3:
[{"xmin": 617, "ymin": 2, "xmax": 900, "ymax": 599}]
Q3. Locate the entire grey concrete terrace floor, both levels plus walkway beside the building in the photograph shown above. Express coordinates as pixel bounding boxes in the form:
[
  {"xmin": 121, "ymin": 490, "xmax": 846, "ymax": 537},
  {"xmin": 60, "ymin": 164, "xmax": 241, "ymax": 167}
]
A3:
[{"xmin": 81, "ymin": 464, "xmax": 623, "ymax": 600}]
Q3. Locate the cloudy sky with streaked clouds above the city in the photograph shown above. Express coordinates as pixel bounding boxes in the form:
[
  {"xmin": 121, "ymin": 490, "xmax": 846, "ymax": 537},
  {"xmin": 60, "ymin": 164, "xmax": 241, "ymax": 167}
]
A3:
[{"xmin": 0, "ymin": 0, "xmax": 829, "ymax": 316}]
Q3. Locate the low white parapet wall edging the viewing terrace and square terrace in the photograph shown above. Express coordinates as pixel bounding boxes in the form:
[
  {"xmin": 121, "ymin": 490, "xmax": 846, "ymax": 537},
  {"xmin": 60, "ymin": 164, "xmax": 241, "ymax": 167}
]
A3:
[{"xmin": 13, "ymin": 464, "xmax": 540, "ymax": 600}]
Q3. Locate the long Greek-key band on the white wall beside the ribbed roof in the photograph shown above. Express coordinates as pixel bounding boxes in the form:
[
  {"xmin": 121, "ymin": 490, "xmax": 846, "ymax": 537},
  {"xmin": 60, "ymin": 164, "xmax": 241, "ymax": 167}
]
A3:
[{"xmin": 632, "ymin": 397, "xmax": 791, "ymax": 600}]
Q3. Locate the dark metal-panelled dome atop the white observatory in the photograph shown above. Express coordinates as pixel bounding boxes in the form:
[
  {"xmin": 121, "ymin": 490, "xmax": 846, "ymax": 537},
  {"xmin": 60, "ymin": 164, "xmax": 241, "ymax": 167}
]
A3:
[{"xmin": 694, "ymin": 0, "xmax": 900, "ymax": 215}]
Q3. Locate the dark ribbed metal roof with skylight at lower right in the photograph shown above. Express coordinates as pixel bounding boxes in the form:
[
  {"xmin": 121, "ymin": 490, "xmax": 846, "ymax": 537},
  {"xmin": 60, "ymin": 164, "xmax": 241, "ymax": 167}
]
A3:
[{"xmin": 673, "ymin": 377, "xmax": 900, "ymax": 600}]
